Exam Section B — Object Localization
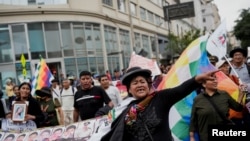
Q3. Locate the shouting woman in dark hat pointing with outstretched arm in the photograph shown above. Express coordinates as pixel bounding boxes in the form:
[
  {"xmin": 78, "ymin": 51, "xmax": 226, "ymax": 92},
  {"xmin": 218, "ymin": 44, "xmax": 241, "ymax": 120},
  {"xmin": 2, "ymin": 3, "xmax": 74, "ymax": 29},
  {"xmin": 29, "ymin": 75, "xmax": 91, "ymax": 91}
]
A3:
[{"xmin": 101, "ymin": 67, "xmax": 219, "ymax": 141}]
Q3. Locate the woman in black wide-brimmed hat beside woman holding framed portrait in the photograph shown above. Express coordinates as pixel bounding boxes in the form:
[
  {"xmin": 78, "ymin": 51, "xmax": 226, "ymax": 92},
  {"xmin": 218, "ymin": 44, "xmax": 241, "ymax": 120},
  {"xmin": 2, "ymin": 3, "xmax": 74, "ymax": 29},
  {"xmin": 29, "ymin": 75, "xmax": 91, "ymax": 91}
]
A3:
[{"xmin": 36, "ymin": 87, "xmax": 64, "ymax": 127}]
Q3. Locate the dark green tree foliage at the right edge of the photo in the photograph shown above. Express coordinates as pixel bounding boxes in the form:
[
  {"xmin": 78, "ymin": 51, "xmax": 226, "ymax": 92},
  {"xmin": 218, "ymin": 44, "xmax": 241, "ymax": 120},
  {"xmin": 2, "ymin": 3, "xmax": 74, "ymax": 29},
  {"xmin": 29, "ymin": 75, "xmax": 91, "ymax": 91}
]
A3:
[{"xmin": 233, "ymin": 8, "xmax": 250, "ymax": 49}]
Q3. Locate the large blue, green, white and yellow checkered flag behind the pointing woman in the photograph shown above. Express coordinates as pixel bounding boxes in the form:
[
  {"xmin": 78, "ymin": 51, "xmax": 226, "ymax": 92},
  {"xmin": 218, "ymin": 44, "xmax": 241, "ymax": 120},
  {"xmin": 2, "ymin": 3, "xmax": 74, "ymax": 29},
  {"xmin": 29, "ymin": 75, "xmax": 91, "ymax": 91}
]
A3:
[{"xmin": 158, "ymin": 35, "xmax": 215, "ymax": 141}]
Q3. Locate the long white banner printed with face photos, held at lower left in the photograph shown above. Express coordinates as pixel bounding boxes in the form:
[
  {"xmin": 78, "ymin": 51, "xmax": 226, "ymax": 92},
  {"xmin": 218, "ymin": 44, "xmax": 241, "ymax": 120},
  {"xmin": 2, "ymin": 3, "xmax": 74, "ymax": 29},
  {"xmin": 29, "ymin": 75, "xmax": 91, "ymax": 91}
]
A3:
[{"xmin": 0, "ymin": 115, "xmax": 113, "ymax": 141}]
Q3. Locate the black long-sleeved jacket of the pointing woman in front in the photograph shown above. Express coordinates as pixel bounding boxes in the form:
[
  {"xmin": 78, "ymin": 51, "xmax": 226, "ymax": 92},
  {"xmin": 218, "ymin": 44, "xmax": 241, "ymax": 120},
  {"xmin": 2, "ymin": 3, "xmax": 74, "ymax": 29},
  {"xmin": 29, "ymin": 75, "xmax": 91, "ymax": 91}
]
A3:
[{"xmin": 101, "ymin": 78, "xmax": 200, "ymax": 141}]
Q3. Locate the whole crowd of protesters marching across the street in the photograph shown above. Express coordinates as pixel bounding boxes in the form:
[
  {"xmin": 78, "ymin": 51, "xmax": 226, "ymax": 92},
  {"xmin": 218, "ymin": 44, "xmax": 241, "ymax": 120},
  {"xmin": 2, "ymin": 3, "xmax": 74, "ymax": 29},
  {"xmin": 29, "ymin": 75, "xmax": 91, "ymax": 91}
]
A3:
[{"xmin": 0, "ymin": 48, "xmax": 250, "ymax": 141}]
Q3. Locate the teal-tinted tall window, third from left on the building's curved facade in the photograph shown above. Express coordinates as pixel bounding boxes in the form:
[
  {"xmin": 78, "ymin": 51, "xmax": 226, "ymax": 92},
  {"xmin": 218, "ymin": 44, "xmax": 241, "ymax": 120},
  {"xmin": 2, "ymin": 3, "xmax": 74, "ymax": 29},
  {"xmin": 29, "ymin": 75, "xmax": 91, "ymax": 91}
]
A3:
[{"xmin": 27, "ymin": 23, "xmax": 46, "ymax": 59}]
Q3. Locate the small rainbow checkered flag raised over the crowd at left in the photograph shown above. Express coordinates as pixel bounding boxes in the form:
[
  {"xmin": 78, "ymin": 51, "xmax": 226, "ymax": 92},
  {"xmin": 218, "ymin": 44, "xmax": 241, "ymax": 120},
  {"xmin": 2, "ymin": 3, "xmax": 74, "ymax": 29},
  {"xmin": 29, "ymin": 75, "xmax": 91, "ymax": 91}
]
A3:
[{"xmin": 31, "ymin": 57, "xmax": 54, "ymax": 96}]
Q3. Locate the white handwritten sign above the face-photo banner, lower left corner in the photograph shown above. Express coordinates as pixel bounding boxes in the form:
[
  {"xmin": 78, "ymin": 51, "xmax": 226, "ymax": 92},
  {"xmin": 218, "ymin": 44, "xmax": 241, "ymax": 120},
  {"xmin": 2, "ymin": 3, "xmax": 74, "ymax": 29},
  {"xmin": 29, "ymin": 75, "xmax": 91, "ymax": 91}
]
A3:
[{"xmin": 1, "ymin": 119, "xmax": 37, "ymax": 133}]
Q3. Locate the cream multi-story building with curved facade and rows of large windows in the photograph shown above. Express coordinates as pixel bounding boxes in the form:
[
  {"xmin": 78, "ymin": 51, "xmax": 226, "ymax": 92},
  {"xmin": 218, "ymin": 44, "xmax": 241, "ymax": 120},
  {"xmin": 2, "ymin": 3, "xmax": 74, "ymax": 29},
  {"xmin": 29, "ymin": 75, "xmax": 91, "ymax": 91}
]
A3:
[{"xmin": 0, "ymin": 0, "xmax": 204, "ymax": 87}]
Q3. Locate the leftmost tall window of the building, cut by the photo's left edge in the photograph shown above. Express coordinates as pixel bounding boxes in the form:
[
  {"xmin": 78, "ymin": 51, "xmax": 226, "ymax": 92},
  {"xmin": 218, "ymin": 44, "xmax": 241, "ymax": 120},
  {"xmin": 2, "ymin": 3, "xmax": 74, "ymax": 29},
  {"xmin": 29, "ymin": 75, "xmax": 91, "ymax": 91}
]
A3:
[{"xmin": 0, "ymin": 25, "xmax": 13, "ymax": 63}]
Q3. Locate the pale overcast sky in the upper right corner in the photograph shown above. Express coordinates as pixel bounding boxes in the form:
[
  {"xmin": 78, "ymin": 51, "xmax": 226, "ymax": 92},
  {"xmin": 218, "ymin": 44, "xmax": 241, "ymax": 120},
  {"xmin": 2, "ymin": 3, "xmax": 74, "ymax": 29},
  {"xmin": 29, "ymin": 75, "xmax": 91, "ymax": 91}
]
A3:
[{"xmin": 214, "ymin": 0, "xmax": 250, "ymax": 31}]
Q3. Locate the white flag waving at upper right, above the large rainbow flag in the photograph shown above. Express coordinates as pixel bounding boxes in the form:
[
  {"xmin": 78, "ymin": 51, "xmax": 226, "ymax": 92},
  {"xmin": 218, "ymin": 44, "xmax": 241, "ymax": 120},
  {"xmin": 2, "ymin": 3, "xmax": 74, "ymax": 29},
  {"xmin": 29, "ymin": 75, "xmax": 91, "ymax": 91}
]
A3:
[{"xmin": 207, "ymin": 20, "xmax": 227, "ymax": 60}]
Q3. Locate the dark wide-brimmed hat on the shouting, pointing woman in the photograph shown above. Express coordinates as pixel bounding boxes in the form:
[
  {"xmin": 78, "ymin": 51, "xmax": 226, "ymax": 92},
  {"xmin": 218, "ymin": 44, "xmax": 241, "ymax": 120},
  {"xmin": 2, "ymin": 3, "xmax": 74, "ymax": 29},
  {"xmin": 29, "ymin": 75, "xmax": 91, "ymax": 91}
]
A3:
[{"xmin": 121, "ymin": 67, "xmax": 152, "ymax": 86}]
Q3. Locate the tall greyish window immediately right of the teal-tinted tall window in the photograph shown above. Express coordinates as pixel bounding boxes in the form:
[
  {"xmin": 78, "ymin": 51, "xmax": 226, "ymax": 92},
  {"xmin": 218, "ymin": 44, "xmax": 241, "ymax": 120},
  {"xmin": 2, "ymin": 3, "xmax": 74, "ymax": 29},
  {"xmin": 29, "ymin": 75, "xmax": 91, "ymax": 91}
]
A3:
[{"xmin": 44, "ymin": 22, "xmax": 62, "ymax": 58}]
